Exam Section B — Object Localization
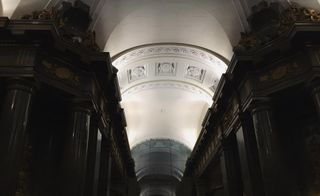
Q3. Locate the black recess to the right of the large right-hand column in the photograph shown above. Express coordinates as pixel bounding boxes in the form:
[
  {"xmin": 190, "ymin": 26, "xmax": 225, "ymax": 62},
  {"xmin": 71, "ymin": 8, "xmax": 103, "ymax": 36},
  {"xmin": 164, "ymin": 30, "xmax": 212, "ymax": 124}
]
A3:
[{"xmin": 274, "ymin": 87, "xmax": 320, "ymax": 195}]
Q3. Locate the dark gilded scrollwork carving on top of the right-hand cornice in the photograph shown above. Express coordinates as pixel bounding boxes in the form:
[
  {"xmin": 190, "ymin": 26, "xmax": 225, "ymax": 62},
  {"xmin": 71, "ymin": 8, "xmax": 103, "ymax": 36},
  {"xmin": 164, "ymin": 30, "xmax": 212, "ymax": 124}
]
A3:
[{"xmin": 234, "ymin": 1, "xmax": 320, "ymax": 52}]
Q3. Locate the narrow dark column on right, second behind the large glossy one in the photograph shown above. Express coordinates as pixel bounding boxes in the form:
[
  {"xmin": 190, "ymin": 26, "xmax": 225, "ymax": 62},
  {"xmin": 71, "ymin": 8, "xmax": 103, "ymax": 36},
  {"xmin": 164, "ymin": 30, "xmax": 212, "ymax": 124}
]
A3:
[{"xmin": 220, "ymin": 134, "xmax": 243, "ymax": 196}]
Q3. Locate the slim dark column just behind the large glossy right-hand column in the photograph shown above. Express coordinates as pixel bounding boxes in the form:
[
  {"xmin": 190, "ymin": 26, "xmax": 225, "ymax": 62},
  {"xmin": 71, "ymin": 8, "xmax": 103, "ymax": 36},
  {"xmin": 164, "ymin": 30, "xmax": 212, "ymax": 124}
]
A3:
[{"xmin": 236, "ymin": 114, "xmax": 264, "ymax": 196}]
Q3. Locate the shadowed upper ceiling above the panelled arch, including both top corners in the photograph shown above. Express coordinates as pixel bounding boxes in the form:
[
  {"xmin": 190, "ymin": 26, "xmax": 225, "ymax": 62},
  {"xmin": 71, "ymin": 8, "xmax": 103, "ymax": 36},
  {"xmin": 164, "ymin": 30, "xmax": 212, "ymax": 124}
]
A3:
[{"xmin": 0, "ymin": 0, "xmax": 320, "ymax": 60}]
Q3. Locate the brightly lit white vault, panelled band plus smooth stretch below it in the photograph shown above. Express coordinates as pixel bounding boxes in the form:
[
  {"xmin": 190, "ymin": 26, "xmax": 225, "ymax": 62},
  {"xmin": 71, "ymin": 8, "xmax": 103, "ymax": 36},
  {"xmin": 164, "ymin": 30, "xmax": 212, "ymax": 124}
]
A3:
[{"xmin": 113, "ymin": 44, "xmax": 226, "ymax": 149}]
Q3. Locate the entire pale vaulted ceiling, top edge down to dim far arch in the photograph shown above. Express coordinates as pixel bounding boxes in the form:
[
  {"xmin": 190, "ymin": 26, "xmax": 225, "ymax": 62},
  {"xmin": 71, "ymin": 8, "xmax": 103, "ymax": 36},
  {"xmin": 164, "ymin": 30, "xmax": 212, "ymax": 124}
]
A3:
[{"xmin": 0, "ymin": 0, "xmax": 320, "ymax": 148}]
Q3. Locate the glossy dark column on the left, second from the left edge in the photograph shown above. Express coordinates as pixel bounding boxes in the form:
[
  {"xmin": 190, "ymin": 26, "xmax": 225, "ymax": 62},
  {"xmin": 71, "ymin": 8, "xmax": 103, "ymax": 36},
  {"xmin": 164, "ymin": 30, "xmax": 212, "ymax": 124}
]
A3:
[{"xmin": 62, "ymin": 103, "xmax": 91, "ymax": 196}]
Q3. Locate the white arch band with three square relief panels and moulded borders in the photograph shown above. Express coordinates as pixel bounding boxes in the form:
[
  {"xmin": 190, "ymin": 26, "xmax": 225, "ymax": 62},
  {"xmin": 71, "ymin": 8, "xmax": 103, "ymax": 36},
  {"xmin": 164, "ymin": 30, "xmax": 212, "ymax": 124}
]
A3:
[{"xmin": 113, "ymin": 44, "xmax": 227, "ymax": 99}]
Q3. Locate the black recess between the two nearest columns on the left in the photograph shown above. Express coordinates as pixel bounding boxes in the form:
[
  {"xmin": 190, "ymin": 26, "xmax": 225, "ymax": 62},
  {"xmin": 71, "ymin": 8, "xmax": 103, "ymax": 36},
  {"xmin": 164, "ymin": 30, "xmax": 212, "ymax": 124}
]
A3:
[{"xmin": 18, "ymin": 85, "xmax": 70, "ymax": 196}]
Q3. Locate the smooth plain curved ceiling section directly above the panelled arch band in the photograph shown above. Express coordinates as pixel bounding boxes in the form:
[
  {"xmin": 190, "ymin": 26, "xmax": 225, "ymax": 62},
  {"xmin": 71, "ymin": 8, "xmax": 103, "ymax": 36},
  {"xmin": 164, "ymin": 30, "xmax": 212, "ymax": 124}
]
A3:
[{"xmin": 105, "ymin": 0, "xmax": 235, "ymax": 59}]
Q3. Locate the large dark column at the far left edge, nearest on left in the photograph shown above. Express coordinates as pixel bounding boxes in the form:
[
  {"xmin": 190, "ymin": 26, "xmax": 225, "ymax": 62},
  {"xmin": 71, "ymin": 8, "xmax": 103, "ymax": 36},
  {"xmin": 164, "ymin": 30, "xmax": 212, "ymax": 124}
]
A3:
[{"xmin": 0, "ymin": 80, "xmax": 34, "ymax": 196}]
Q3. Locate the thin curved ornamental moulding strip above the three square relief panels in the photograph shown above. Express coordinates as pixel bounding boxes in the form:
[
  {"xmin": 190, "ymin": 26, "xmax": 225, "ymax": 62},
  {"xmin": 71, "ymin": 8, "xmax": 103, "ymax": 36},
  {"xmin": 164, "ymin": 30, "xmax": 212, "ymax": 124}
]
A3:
[{"xmin": 113, "ymin": 45, "xmax": 225, "ymax": 68}]
